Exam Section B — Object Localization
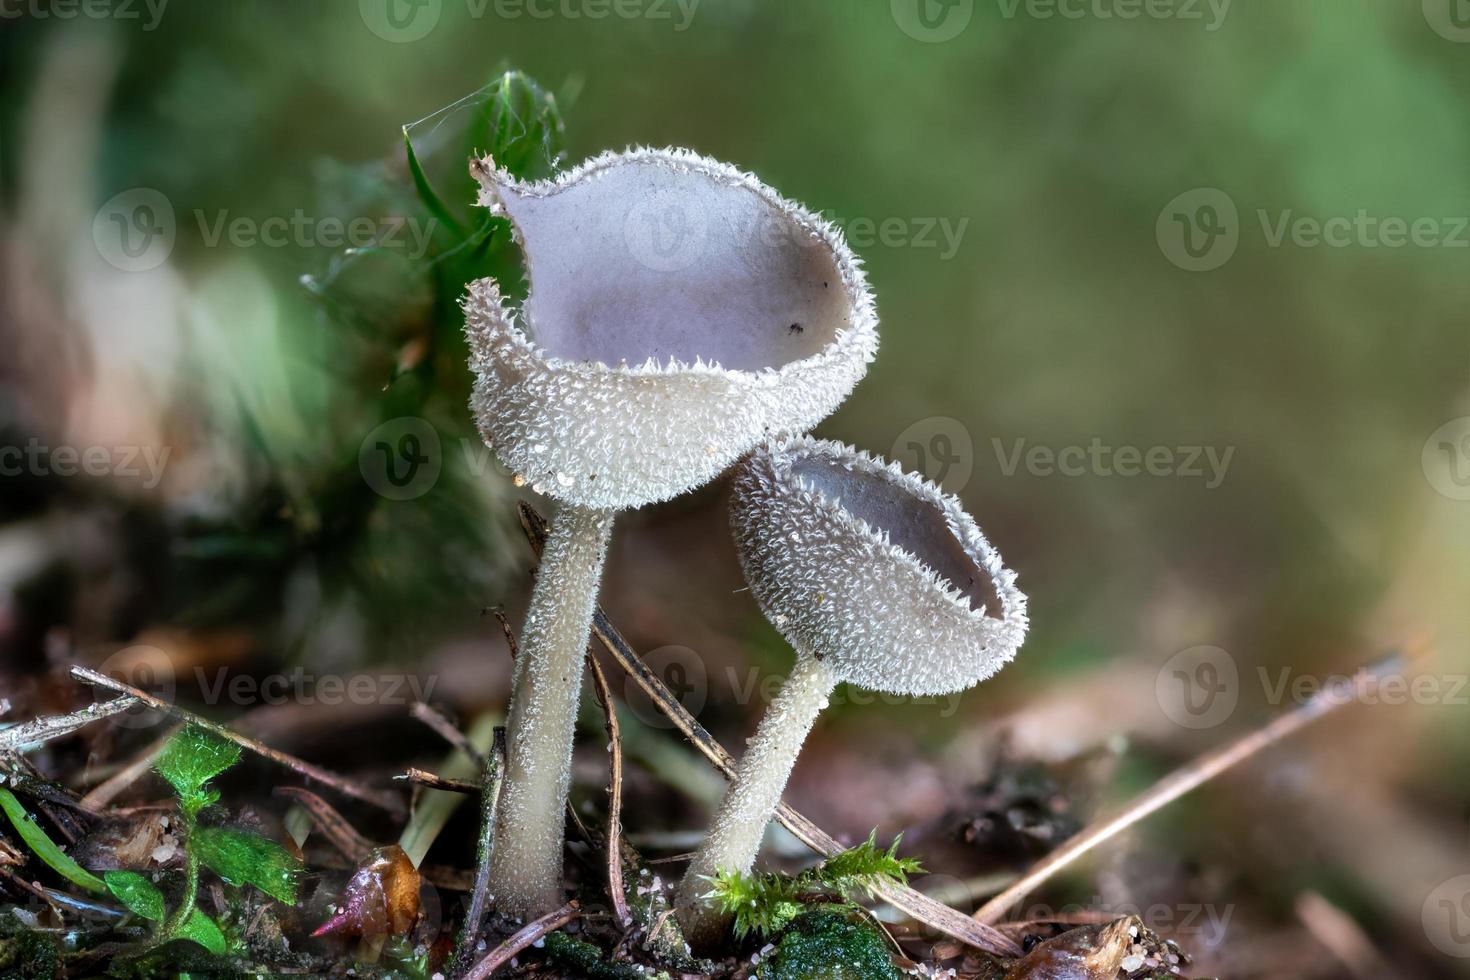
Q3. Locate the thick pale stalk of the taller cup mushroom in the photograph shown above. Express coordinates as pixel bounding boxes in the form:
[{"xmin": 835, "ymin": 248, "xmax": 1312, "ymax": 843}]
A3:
[{"xmin": 490, "ymin": 504, "xmax": 613, "ymax": 918}]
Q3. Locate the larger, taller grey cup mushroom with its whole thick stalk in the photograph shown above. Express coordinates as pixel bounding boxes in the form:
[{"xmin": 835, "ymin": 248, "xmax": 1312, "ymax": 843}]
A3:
[{"xmin": 465, "ymin": 150, "xmax": 878, "ymax": 915}]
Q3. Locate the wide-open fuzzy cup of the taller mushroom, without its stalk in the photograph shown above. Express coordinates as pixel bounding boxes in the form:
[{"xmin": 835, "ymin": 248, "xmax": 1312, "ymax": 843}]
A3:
[{"xmin": 465, "ymin": 150, "xmax": 878, "ymax": 508}]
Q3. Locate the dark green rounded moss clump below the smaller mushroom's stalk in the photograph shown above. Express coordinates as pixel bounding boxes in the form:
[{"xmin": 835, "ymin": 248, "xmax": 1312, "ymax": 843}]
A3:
[{"xmin": 757, "ymin": 905, "xmax": 900, "ymax": 980}]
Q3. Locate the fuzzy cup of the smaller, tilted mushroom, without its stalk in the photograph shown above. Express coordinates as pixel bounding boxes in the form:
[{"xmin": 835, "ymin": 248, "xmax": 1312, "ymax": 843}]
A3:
[{"xmin": 731, "ymin": 436, "xmax": 1026, "ymax": 695}]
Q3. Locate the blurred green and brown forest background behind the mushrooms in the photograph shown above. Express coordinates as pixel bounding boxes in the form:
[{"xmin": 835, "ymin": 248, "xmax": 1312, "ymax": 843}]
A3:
[{"xmin": 0, "ymin": 0, "xmax": 1470, "ymax": 977}]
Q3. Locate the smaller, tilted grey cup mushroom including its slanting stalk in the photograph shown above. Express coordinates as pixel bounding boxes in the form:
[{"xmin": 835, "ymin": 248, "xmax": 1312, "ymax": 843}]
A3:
[{"xmin": 678, "ymin": 436, "xmax": 1026, "ymax": 948}]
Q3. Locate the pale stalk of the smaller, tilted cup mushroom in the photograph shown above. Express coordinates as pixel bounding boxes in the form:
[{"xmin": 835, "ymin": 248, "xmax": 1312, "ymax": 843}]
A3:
[{"xmin": 678, "ymin": 655, "xmax": 838, "ymax": 949}]
